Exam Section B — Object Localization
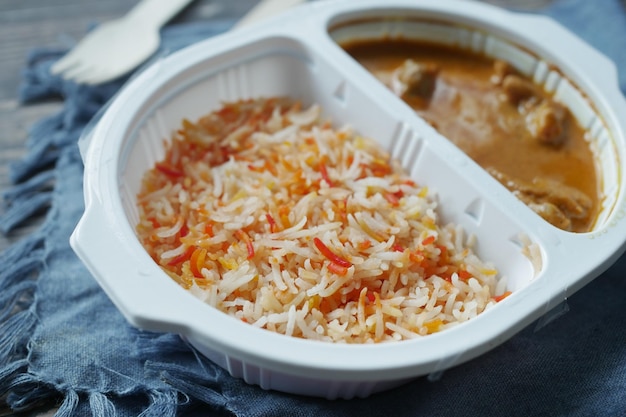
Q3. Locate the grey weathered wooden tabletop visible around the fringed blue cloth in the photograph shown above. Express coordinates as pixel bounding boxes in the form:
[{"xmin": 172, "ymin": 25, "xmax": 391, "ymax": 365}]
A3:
[{"xmin": 0, "ymin": 0, "xmax": 552, "ymax": 415}]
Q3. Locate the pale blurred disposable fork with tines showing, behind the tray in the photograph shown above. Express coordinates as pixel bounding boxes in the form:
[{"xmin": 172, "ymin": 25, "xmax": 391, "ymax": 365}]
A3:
[{"xmin": 50, "ymin": 0, "xmax": 191, "ymax": 84}]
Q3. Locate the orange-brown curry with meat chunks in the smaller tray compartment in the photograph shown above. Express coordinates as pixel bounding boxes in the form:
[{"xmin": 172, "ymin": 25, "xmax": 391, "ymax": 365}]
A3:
[{"xmin": 342, "ymin": 39, "xmax": 601, "ymax": 232}]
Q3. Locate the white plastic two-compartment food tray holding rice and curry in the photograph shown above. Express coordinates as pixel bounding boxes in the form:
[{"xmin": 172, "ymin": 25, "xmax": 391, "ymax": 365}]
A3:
[{"xmin": 71, "ymin": 0, "xmax": 626, "ymax": 398}]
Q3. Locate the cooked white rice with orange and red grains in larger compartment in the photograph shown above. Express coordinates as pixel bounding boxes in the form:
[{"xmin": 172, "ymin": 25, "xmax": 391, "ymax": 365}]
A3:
[{"xmin": 137, "ymin": 98, "xmax": 508, "ymax": 343}]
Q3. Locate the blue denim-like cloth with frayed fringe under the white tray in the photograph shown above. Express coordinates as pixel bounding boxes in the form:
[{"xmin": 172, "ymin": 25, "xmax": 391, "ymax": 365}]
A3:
[{"xmin": 0, "ymin": 0, "xmax": 626, "ymax": 417}]
